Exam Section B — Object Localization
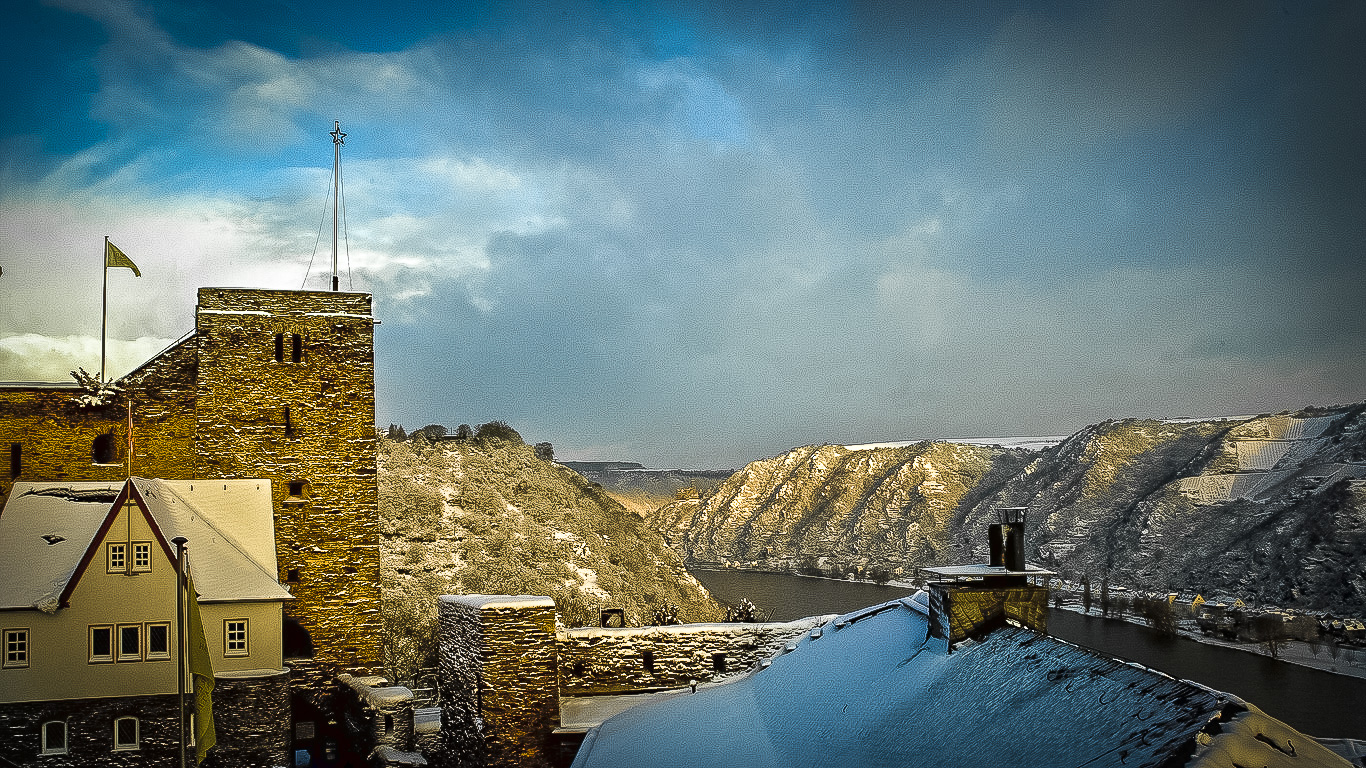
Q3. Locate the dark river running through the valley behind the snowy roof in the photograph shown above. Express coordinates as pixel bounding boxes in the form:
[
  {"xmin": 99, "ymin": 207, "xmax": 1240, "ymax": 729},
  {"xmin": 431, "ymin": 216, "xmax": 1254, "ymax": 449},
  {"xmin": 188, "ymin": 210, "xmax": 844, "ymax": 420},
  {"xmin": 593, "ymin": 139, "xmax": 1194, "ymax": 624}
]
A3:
[{"xmin": 693, "ymin": 570, "xmax": 1366, "ymax": 739}]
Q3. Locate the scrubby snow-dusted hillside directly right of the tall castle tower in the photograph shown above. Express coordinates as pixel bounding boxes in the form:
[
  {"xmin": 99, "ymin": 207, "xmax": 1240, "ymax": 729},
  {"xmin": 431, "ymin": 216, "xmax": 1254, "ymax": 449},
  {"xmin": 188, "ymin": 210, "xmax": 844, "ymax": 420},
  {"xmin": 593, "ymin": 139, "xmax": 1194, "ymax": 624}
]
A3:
[{"xmin": 378, "ymin": 437, "xmax": 724, "ymax": 672}]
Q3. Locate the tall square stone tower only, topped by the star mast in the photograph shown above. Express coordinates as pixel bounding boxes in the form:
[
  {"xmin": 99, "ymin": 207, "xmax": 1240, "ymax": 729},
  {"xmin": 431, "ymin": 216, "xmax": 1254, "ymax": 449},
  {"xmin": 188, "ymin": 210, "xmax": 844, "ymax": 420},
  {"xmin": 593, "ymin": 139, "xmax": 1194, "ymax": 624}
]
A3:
[{"xmin": 194, "ymin": 288, "xmax": 381, "ymax": 670}]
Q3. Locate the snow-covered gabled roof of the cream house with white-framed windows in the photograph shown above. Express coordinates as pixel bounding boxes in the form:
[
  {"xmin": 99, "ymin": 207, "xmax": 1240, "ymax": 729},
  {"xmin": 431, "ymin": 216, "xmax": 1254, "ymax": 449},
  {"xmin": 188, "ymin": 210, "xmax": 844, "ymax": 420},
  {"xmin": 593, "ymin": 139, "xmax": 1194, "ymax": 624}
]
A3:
[{"xmin": 0, "ymin": 477, "xmax": 291, "ymax": 612}]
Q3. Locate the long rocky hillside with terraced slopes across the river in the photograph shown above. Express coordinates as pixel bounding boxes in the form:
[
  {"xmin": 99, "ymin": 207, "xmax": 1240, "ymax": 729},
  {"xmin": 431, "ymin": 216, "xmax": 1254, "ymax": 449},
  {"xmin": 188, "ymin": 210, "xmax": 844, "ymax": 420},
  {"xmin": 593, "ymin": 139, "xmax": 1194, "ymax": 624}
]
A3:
[{"xmin": 649, "ymin": 404, "xmax": 1366, "ymax": 614}]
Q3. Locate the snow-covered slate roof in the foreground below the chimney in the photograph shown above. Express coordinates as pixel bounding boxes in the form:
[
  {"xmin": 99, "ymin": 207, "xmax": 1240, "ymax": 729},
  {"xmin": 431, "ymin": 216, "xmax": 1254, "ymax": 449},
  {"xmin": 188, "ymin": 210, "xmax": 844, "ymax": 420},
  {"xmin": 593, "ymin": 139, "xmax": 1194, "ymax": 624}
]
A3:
[{"xmin": 574, "ymin": 599, "xmax": 1332, "ymax": 768}]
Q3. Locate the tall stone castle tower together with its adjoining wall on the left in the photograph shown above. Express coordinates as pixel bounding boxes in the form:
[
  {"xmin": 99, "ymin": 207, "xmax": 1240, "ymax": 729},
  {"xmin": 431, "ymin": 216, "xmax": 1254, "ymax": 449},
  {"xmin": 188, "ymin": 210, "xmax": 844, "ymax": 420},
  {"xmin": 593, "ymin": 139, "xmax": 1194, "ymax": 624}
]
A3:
[{"xmin": 0, "ymin": 288, "xmax": 381, "ymax": 672}]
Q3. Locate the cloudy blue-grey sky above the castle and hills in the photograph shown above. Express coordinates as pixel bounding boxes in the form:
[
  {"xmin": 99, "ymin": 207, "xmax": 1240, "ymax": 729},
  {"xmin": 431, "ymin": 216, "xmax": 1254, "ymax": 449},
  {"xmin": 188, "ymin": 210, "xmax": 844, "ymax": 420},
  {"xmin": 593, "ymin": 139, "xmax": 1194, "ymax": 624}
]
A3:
[{"xmin": 0, "ymin": 0, "xmax": 1366, "ymax": 469}]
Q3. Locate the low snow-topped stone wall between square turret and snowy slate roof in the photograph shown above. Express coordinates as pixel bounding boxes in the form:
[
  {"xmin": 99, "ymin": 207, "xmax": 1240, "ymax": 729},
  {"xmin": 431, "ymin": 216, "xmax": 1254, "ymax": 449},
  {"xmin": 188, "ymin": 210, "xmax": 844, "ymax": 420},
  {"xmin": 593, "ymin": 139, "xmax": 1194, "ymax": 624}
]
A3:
[{"xmin": 557, "ymin": 618, "xmax": 822, "ymax": 696}]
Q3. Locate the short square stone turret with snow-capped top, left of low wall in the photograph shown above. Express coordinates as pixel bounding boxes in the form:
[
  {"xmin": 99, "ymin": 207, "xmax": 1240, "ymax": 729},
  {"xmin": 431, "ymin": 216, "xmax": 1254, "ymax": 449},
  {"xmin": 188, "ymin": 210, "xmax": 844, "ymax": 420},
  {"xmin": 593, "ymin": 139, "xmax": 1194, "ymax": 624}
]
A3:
[{"xmin": 437, "ymin": 594, "xmax": 560, "ymax": 768}]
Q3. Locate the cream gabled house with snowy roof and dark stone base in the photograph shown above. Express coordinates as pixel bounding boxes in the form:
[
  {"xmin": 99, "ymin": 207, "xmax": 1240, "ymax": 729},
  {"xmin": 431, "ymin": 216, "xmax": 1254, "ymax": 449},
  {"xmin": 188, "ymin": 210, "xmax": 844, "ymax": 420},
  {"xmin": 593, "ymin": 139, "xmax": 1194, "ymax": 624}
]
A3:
[{"xmin": 0, "ymin": 478, "xmax": 291, "ymax": 765}]
